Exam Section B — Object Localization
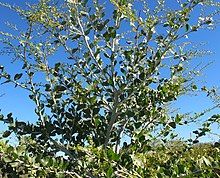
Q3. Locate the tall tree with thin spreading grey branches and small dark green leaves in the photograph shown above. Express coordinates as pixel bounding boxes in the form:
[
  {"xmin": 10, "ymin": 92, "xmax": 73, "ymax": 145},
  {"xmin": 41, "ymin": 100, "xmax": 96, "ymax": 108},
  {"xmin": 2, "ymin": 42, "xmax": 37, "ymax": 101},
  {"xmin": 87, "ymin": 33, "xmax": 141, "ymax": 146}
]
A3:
[{"xmin": 0, "ymin": 0, "xmax": 219, "ymax": 177}]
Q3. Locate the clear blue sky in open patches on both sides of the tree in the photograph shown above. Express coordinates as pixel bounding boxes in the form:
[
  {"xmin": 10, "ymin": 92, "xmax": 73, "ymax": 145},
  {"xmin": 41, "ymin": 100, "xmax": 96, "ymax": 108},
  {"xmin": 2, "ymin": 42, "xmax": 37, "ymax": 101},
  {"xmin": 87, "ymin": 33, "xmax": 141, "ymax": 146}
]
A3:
[{"xmin": 0, "ymin": 0, "xmax": 220, "ymax": 141}]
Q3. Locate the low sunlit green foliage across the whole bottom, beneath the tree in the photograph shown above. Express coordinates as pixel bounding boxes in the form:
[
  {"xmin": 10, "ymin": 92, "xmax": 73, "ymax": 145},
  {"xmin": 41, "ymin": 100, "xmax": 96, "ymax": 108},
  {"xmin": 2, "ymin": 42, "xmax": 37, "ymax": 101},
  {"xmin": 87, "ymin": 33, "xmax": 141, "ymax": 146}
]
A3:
[{"xmin": 0, "ymin": 138, "xmax": 220, "ymax": 178}]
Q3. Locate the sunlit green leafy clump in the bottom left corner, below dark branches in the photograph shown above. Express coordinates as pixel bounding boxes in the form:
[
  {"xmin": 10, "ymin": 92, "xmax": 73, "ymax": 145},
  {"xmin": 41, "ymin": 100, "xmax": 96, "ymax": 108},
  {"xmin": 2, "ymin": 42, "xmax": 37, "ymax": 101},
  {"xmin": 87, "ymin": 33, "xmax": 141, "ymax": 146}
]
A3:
[{"xmin": 0, "ymin": 139, "xmax": 71, "ymax": 177}]
